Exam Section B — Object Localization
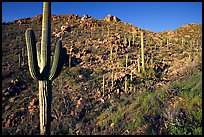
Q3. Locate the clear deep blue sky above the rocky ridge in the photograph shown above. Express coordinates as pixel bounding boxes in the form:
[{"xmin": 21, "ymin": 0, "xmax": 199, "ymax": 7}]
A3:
[{"xmin": 2, "ymin": 2, "xmax": 202, "ymax": 32}]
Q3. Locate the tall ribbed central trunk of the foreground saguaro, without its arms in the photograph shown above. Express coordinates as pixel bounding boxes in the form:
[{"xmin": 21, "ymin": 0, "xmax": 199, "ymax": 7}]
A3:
[{"xmin": 39, "ymin": 3, "xmax": 52, "ymax": 135}]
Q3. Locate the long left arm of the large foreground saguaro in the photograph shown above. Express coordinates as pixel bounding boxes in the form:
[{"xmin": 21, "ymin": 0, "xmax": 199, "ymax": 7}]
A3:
[{"xmin": 25, "ymin": 28, "xmax": 41, "ymax": 80}]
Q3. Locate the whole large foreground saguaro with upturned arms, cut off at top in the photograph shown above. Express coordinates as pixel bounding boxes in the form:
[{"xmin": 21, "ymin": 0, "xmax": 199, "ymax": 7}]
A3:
[{"xmin": 25, "ymin": 2, "xmax": 66, "ymax": 135}]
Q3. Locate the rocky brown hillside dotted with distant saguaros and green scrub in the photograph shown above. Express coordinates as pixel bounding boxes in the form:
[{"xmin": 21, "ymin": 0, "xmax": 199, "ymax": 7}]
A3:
[{"xmin": 2, "ymin": 14, "xmax": 202, "ymax": 135}]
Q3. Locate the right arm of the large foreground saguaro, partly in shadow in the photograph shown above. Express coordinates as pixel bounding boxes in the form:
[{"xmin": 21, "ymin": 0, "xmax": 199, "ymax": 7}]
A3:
[{"xmin": 49, "ymin": 40, "xmax": 66, "ymax": 81}]
